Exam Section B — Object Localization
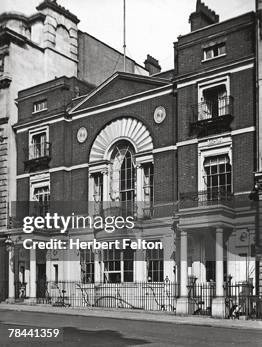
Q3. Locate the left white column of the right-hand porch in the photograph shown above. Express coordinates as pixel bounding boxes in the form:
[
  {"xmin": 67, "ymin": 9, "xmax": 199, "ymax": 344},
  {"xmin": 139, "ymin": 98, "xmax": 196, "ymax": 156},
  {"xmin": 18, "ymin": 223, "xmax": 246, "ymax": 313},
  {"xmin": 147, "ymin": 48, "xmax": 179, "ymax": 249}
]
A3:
[{"xmin": 180, "ymin": 230, "xmax": 188, "ymax": 297}]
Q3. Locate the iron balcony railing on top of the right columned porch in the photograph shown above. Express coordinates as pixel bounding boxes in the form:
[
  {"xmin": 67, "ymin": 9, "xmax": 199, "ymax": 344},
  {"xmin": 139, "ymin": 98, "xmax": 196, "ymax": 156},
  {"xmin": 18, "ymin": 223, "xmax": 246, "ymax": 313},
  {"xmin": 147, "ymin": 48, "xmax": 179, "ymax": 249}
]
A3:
[{"xmin": 179, "ymin": 188, "xmax": 234, "ymax": 209}]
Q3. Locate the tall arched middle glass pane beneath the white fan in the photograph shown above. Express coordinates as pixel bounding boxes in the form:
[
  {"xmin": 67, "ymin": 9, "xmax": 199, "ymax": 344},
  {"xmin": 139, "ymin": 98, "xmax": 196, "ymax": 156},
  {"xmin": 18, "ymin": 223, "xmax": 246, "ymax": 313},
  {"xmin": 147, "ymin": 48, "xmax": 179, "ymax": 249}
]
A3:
[{"xmin": 109, "ymin": 141, "xmax": 135, "ymax": 215}]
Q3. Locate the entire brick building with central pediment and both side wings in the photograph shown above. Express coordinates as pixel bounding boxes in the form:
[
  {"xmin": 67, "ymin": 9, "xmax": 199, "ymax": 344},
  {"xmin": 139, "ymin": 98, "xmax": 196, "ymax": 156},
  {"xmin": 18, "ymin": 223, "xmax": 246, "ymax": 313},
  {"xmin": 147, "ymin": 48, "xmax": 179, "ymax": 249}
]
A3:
[{"xmin": 3, "ymin": 1, "xmax": 259, "ymax": 317}]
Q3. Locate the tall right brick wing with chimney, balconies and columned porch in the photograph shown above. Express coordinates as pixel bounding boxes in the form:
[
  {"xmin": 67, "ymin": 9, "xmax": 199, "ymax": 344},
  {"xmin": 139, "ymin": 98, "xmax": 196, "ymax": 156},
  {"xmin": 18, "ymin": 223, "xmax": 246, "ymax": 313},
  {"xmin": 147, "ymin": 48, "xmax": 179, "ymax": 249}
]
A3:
[{"xmin": 175, "ymin": 2, "xmax": 256, "ymax": 316}]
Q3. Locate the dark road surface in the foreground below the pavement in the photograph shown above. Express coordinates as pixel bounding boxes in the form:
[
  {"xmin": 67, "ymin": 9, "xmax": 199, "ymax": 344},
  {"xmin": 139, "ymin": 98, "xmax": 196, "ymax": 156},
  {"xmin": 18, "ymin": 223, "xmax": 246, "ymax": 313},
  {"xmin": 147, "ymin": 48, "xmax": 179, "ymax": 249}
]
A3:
[{"xmin": 0, "ymin": 309, "xmax": 262, "ymax": 347}]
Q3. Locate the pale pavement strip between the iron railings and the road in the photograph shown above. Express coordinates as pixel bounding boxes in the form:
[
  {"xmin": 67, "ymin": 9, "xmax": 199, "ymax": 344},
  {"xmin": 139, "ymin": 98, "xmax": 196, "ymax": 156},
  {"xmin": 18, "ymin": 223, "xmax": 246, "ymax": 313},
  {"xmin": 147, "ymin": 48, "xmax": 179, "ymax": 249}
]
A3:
[{"xmin": 0, "ymin": 303, "xmax": 262, "ymax": 331}]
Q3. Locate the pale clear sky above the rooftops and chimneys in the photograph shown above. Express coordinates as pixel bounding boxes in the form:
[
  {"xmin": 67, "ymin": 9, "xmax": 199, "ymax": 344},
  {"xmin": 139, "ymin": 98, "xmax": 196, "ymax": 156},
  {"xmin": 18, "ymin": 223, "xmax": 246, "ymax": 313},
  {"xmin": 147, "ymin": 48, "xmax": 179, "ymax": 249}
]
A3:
[{"xmin": 0, "ymin": 0, "xmax": 255, "ymax": 70}]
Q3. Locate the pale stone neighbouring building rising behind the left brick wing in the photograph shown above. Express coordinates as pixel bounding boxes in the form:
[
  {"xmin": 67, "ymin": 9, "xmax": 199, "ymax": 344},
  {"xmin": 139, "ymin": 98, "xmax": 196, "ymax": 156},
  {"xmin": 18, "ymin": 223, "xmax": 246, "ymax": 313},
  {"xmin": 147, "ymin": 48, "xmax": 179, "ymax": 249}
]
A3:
[{"xmin": 0, "ymin": 0, "xmax": 148, "ymax": 302}]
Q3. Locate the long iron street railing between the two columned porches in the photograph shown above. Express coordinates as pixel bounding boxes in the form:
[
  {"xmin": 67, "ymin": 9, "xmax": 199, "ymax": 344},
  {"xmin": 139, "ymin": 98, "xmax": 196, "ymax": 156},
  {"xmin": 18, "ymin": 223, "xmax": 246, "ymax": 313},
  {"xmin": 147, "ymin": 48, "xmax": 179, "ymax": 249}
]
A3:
[{"xmin": 36, "ymin": 281, "xmax": 179, "ymax": 312}]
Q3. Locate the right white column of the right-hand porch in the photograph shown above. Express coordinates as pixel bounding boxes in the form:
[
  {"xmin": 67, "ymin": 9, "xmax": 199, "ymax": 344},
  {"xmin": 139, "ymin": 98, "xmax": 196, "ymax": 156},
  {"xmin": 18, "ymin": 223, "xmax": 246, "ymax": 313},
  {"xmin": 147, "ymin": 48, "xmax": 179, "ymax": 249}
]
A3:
[{"xmin": 216, "ymin": 228, "xmax": 224, "ymax": 297}]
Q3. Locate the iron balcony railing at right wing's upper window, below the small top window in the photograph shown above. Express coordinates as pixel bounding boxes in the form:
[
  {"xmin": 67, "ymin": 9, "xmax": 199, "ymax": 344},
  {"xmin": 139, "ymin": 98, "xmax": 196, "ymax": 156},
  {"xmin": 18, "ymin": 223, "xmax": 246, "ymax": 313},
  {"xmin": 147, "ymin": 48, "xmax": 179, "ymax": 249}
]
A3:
[{"xmin": 192, "ymin": 96, "xmax": 233, "ymax": 123}]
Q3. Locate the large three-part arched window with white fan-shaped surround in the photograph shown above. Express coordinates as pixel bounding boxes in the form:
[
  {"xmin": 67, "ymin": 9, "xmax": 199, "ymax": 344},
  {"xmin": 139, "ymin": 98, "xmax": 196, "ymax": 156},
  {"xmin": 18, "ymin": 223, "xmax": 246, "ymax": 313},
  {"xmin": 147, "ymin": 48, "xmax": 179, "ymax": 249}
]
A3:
[{"xmin": 89, "ymin": 117, "xmax": 154, "ymax": 219}]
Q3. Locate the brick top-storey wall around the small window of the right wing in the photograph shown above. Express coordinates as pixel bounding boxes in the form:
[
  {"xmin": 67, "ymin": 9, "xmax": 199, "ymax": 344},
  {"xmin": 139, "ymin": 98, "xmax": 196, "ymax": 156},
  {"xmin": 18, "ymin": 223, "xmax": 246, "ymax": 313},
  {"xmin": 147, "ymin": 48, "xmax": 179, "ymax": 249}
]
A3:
[{"xmin": 177, "ymin": 13, "xmax": 255, "ymax": 75}]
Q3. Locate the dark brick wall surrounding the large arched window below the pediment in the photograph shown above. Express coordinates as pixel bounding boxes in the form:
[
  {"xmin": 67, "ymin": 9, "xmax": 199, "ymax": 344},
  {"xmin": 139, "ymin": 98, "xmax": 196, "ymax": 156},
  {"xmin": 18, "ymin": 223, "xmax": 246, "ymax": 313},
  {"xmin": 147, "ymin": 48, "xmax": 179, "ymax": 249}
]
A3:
[{"xmin": 17, "ymin": 95, "xmax": 176, "ymax": 218}]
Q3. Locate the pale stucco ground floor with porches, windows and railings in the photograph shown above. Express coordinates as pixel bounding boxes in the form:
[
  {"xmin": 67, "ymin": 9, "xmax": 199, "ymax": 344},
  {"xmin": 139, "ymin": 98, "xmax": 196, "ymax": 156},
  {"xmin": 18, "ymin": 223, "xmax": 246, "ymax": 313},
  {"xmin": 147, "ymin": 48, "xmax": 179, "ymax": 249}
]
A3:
[{"xmin": 1, "ymin": 220, "xmax": 262, "ymax": 317}]
